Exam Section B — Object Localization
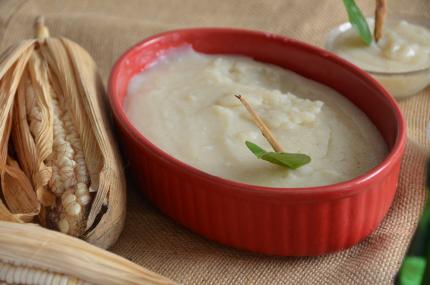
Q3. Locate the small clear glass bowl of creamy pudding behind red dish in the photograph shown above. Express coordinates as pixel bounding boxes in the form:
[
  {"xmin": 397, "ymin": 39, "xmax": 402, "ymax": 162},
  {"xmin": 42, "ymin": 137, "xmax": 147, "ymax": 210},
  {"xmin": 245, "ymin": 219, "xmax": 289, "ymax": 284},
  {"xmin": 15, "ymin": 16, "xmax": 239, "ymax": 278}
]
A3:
[{"xmin": 326, "ymin": 19, "xmax": 430, "ymax": 98}]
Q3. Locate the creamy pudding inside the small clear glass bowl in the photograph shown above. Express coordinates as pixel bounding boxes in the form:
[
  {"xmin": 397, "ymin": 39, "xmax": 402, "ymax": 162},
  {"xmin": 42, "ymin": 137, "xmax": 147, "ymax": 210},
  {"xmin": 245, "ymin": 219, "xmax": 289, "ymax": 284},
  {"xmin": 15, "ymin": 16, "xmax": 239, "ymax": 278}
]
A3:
[{"xmin": 329, "ymin": 20, "xmax": 430, "ymax": 73}]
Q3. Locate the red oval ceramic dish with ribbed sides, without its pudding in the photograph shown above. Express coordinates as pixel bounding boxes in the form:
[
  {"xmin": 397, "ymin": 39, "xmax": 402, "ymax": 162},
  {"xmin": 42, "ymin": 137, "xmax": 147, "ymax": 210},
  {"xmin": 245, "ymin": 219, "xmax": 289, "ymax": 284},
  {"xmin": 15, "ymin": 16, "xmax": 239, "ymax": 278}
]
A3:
[{"xmin": 109, "ymin": 28, "xmax": 406, "ymax": 256}]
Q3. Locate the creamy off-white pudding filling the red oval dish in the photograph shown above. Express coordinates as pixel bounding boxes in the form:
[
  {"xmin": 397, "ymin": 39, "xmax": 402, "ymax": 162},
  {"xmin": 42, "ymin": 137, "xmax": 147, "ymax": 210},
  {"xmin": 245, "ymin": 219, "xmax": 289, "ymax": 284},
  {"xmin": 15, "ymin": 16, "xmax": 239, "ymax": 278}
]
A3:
[{"xmin": 124, "ymin": 47, "xmax": 387, "ymax": 187}]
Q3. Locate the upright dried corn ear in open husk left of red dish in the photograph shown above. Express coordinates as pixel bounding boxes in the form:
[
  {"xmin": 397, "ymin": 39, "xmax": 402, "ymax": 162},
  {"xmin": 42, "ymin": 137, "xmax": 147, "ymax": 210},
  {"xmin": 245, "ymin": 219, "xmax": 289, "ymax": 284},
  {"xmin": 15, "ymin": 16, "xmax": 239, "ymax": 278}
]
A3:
[{"xmin": 0, "ymin": 16, "xmax": 126, "ymax": 248}]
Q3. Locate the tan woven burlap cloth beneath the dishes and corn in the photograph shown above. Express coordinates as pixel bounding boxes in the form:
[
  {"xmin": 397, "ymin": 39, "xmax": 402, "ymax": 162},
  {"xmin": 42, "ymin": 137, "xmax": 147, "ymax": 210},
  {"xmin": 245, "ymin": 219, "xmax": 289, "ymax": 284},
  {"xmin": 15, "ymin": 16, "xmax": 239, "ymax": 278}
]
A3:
[{"xmin": 0, "ymin": 0, "xmax": 430, "ymax": 284}]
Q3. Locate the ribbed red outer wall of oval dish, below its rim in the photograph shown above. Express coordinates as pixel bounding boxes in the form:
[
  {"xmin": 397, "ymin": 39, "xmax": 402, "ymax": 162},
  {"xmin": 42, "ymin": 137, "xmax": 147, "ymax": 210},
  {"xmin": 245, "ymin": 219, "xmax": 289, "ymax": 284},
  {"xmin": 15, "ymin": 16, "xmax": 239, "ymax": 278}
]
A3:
[{"xmin": 116, "ymin": 129, "xmax": 400, "ymax": 256}]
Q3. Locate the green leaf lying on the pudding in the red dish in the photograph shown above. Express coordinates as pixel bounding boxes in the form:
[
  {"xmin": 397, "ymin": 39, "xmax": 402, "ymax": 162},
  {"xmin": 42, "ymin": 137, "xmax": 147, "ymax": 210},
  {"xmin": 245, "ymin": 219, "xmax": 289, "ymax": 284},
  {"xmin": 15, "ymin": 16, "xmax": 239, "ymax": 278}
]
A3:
[{"xmin": 245, "ymin": 141, "xmax": 311, "ymax": 169}]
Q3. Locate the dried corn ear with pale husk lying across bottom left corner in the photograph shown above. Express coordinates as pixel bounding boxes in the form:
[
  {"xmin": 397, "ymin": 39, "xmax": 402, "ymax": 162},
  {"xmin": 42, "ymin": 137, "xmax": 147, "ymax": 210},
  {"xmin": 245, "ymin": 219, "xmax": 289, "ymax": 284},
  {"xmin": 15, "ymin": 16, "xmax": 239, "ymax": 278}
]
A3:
[{"xmin": 0, "ymin": 222, "xmax": 174, "ymax": 285}]
